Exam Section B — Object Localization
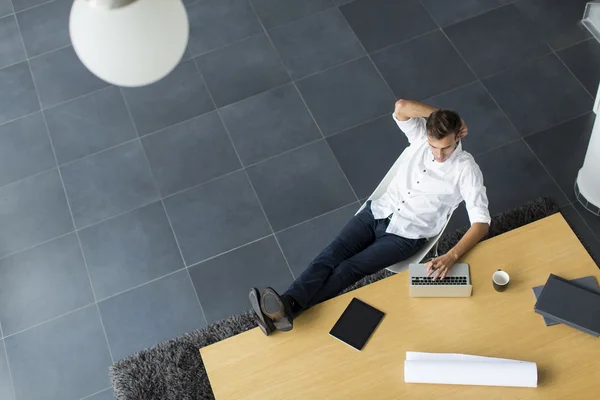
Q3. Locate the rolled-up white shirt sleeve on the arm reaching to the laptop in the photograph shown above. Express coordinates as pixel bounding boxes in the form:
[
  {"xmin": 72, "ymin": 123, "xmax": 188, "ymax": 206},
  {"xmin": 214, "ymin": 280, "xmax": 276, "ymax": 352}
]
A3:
[{"xmin": 459, "ymin": 163, "xmax": 492, "ymax": 225}]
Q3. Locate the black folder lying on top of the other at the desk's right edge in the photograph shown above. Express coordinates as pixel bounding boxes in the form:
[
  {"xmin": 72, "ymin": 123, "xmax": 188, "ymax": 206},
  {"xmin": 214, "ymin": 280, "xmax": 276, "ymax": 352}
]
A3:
[{"xmin": 534, "ymin": 274, "xmax": 600, "ymax": 337}]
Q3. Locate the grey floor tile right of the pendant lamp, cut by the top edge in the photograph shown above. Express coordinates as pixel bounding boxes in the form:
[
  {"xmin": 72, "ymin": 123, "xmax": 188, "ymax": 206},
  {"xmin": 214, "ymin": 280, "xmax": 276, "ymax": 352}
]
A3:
[{"xmin": 187, "ymin": 0, "xmax": 262, "ymax": 56}]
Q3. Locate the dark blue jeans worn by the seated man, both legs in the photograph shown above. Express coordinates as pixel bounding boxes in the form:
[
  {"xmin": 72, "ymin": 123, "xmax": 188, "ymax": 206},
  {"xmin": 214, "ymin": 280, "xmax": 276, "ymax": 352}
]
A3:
[{"xmin": 285, "ymin": 202, "xmax": 425, "ymax": 309}]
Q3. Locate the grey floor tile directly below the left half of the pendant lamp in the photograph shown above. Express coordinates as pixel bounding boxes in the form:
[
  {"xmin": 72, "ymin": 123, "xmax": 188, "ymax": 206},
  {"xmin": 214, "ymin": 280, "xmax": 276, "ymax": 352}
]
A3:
[{"xmin": 44, "ymin": 86, "xmax": 137, "ymax": 164}]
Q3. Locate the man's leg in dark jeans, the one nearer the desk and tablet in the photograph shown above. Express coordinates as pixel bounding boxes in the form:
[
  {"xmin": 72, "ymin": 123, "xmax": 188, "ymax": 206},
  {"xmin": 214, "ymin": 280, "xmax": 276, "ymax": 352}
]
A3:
[{"xmin": 305, "ymin": 220, "xmax": 425, "ymax": 308}]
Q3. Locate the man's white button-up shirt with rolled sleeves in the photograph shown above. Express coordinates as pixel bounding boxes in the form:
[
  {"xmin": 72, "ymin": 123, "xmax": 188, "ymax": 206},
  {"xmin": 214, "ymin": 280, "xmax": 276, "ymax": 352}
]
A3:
[{"xmin": 371, "ymin": 112, "xmax": 491, "ymax": 239}]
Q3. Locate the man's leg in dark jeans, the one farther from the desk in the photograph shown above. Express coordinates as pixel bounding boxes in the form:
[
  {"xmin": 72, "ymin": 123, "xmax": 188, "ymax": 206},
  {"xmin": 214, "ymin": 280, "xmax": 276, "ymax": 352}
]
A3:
[{"xmin": 284, "ymin": 204, "xmax": 377, "ymax": 309}]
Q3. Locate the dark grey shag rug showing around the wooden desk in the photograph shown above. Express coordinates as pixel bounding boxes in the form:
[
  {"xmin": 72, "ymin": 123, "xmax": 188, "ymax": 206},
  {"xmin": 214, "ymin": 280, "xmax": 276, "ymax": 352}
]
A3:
[{"xmin": 110, "ymin": 198, "xmax": 559, "ymax": 400}]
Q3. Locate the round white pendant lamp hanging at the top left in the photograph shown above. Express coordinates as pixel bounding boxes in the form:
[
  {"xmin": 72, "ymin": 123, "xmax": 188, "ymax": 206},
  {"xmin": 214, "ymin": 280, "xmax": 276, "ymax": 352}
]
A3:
[{"xmin": 69, "ymin": 0, "xmax": 189, "ymax": 86}]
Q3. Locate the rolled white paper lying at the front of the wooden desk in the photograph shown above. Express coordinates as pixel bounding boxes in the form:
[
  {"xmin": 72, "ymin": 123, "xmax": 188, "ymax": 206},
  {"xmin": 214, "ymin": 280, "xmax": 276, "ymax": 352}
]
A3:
[{"xmin": 404, "ymin": 352, "xmax": 537, "ymax": 387}]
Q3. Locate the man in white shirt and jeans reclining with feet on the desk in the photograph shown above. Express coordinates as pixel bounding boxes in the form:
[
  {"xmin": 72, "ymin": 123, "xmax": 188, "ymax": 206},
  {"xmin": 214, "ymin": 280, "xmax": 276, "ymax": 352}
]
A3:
[{"xmin": 249, "ymin": 100, "xmax": 490, "ymax": 335}]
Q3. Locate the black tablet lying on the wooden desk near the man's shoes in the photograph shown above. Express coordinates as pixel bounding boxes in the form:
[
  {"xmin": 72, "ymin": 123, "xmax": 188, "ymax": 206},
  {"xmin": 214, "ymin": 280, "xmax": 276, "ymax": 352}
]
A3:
[{"xmin": 329, "ymin": 297, "xmax": 385, "ymax": 350}]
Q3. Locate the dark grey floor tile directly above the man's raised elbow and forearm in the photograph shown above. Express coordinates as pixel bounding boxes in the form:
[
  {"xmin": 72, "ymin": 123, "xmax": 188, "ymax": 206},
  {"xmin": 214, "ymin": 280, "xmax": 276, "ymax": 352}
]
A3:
[{"xmin": 372, "ymin": 31, "xmax": 476, "ymax": 100}]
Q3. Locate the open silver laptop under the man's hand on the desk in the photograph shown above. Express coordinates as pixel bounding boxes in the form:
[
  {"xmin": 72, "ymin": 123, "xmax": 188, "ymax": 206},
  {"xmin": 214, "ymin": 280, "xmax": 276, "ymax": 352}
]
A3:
[{"xmin": 408, "ymin": 264, "xmax": 473, "ymax": 297}]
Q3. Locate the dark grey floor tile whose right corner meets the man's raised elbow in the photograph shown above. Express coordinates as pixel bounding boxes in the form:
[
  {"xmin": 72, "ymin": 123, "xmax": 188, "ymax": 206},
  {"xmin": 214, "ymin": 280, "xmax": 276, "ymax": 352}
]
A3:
[{"xmin": 297, "ymin": 57, "xmax": 395, "ymax": 136}]
